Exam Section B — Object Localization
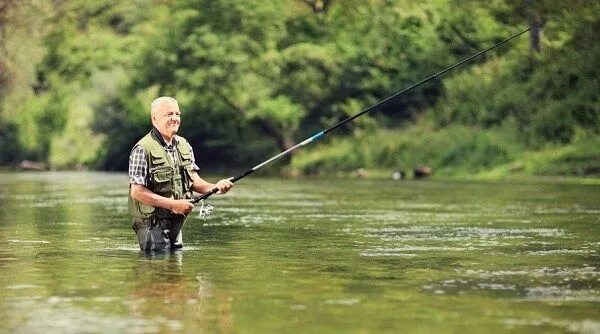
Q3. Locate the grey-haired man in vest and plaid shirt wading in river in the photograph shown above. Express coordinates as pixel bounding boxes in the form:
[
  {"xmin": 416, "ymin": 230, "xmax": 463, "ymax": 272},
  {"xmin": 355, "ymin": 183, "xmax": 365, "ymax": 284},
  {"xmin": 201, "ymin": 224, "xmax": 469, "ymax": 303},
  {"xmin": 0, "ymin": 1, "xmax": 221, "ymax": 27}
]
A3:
[{"xmin": 129, "ymin": 96, "xmax": 233, "ymax": 251}]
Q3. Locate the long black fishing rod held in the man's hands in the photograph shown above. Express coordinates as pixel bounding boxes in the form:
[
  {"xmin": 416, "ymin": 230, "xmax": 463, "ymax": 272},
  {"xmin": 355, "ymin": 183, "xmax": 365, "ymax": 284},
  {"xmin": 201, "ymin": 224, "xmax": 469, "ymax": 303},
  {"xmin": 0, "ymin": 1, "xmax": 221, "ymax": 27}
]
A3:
[{"xmin": 191, "ymin": 23, "xmax": 533, "ymax": 203}]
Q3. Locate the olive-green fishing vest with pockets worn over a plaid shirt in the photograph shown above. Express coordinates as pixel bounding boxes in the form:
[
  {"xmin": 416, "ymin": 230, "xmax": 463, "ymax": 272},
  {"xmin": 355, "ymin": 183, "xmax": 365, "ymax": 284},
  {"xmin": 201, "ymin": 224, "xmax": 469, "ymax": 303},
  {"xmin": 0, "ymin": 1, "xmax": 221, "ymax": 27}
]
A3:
[{"xmin": 129, "ymin": 130, "xmax": 194, "ymax": 219}]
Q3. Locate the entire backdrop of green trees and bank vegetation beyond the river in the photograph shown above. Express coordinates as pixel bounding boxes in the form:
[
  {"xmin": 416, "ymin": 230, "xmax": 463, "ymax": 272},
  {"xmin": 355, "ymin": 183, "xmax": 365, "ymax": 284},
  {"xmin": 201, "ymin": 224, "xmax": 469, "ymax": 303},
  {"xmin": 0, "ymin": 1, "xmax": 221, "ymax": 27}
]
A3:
[{"xmin": 0, "ymin": 0, "xmax": 600, "ymax": 177}]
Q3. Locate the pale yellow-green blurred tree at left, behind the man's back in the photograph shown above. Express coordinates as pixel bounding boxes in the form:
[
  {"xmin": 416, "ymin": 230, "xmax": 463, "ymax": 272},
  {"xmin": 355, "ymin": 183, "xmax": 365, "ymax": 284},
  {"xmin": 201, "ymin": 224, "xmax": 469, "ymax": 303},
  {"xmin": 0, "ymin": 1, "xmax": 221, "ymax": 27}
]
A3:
[{"xmin": 26, "ymin": 0, "xmax": 161, "ymax": 168}]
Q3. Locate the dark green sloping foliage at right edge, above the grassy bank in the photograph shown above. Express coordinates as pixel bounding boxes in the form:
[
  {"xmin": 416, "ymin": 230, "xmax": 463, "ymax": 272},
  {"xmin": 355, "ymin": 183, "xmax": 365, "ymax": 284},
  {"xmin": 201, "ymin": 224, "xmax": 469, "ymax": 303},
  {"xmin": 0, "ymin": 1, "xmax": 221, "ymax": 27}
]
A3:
[{"xmin": 429, "ymin": 1, "xmax": 600, "ymax": 148}]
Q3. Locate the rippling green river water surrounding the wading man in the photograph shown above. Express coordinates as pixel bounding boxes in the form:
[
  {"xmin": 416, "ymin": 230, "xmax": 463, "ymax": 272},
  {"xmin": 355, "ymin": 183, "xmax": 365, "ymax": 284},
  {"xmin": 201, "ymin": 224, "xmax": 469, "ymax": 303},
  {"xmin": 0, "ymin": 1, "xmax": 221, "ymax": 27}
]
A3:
[{"xmin": 0, "ymin": 172, "xmax": 600, "ymax": 333}]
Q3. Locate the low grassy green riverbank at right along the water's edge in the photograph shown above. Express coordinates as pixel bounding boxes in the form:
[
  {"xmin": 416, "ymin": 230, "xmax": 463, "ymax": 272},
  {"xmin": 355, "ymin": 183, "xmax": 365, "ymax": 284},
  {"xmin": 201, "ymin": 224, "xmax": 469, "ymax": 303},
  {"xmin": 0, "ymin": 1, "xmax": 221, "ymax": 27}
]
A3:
[{"xmin": 289, "ymin": 124, "xmax": 600, "ymax": 180}]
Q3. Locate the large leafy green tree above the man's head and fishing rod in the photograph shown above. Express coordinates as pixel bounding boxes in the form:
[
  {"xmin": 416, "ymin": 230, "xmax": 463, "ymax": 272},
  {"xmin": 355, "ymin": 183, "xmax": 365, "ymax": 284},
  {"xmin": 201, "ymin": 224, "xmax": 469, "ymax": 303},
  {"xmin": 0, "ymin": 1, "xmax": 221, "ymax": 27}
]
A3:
[{"xmin": 134, "ymin": 0, "xmax": 482, "ymax": 158}]
